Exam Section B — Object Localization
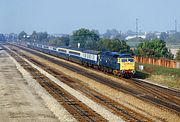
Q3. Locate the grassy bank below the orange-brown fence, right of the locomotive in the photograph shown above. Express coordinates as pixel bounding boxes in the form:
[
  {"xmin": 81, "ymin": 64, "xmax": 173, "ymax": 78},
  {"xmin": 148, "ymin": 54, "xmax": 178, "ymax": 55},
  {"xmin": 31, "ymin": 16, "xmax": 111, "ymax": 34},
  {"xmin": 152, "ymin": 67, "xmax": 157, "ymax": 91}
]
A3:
[{"xmin": 135, "ymin": 63, "xmax": 180, "ymax": 89}]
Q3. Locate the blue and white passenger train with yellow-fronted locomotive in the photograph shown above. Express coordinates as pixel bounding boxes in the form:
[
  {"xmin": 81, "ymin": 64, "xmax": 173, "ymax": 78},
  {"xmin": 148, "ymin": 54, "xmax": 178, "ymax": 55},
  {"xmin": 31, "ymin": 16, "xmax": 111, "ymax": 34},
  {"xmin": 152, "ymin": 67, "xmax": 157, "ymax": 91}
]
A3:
[{"xmin": 27, "ymin": 43, "xmax": 135, "ymax": 78}]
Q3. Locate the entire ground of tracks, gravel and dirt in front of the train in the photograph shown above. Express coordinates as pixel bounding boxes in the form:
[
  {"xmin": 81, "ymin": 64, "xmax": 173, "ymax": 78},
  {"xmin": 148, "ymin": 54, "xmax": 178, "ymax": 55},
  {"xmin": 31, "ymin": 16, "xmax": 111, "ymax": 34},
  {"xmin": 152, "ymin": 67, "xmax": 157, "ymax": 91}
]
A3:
[{"xmin": 0, "ymin": 44, "xmax": 180, "ymax": 122}]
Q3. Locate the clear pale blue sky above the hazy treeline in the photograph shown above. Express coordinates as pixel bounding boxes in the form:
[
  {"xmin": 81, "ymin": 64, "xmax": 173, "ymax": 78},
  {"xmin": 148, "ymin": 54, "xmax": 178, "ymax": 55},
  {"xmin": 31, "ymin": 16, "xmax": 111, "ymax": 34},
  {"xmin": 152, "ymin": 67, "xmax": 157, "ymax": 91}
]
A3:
[{"xmin": 0, "ymin": 0, "xmax": 180, "ymax": 34}]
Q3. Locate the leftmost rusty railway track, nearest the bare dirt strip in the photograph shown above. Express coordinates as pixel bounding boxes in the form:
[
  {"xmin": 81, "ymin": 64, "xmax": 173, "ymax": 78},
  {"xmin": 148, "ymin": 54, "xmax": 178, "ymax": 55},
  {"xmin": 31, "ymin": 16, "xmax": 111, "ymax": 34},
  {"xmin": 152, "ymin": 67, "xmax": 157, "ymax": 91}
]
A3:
[{"xmin": 6, "ymin": 46, "xmax": 107, "ymax": 122}]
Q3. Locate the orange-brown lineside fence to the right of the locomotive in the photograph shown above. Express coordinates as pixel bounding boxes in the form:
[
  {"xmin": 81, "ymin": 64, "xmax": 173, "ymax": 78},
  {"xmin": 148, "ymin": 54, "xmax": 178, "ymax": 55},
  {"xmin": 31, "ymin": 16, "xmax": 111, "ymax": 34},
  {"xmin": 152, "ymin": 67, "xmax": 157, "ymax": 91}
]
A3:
[{"xmin": 134, "ymin": 56, "xmax": 180, "ymax": 69}]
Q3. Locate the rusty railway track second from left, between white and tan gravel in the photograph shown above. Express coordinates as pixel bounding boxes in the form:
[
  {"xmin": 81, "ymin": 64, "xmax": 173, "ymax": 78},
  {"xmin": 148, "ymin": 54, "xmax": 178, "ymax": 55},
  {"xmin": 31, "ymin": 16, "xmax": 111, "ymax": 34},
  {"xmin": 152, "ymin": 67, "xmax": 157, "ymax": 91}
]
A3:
[{"xmin": 3, "ymin": 46, "xmax": 152, "ymax": 122}]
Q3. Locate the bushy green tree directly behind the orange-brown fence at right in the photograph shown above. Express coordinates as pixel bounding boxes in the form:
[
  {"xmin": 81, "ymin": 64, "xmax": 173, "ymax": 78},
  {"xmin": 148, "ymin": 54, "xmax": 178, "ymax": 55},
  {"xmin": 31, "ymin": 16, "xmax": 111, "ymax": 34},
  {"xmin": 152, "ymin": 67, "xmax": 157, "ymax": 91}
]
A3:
[{"xmin": 135, "ymin": 39, "xmax": 173, "ymax": 59}]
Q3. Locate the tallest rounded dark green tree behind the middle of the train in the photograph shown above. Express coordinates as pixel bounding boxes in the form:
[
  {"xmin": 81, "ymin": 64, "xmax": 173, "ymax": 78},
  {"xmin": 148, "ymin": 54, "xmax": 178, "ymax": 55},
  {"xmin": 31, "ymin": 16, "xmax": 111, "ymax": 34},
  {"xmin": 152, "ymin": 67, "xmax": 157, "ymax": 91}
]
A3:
[{"xmin": 70, "ymin": 28, "xmax": 100, "ymax": 49}]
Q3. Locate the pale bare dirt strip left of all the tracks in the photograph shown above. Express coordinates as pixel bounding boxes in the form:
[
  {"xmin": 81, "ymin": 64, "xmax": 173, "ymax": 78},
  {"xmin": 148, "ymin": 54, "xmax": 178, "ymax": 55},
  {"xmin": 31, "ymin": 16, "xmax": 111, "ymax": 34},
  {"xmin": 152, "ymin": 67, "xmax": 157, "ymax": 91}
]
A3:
[{"xmin": 0, "ymin": 50, "xmax": 59, "ymax": 122}]
